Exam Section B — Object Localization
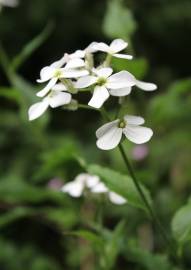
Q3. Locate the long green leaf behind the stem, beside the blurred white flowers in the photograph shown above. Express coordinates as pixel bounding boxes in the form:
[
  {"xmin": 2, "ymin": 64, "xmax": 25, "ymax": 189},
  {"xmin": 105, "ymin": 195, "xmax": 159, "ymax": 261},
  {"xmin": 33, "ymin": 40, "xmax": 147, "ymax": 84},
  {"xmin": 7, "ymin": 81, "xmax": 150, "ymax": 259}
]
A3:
[{"xmin": 87, "ymin": 165, "xmax": 151, "ymax": 211}]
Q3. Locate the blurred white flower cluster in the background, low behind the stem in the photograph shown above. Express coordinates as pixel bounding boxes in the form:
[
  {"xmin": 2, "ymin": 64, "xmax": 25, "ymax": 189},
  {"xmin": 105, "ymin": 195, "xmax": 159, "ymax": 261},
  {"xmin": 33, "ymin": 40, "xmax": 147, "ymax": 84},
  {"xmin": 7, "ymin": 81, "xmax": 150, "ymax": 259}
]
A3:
[{"xmin": 61, "ymin": 173, "xmax": 127, "ymax": 205}]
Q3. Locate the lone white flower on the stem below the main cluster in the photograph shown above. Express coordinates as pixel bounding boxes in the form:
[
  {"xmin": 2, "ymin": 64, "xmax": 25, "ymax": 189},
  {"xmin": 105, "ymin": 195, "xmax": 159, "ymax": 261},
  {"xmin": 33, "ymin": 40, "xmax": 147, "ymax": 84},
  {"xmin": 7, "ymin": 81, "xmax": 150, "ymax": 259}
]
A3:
[{"xmin": 96, "ymin": 115, "xmax": 153, "ymax": 150}]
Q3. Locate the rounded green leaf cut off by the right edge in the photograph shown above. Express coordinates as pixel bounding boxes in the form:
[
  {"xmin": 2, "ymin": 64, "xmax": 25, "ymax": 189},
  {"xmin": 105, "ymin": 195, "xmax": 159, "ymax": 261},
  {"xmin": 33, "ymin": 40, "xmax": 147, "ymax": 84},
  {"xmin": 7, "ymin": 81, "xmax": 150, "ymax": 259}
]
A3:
[{"xmin": 172, "ymin": 203, "xmax": 191, "ymax": 244}]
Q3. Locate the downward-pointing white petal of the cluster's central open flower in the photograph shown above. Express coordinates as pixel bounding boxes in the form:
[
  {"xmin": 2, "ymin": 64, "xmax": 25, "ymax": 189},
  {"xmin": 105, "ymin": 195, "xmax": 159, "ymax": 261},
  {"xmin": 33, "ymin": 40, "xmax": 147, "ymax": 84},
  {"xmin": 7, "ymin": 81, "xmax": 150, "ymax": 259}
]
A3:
[{"xmin": 88, "ymin": 86, "xmax": 109, "ymax": 109}]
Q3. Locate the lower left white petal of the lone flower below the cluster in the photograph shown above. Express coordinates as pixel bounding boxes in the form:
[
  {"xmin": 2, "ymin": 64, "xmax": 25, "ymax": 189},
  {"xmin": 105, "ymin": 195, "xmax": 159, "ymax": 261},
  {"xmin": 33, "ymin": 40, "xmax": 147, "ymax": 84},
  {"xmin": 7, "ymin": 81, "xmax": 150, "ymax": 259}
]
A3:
[{"xmin": 96, "ymin": 126, "xmax": 122, "ymax": 150}]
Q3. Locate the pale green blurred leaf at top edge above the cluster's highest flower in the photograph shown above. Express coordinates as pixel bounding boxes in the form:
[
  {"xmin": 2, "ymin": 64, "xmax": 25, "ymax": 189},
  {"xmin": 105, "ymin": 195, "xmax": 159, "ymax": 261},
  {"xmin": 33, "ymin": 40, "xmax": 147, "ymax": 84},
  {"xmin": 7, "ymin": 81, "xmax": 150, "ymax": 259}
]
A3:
[{"xmin": 103, "ymin": 0, "xmax": 137, "ymax": 40}]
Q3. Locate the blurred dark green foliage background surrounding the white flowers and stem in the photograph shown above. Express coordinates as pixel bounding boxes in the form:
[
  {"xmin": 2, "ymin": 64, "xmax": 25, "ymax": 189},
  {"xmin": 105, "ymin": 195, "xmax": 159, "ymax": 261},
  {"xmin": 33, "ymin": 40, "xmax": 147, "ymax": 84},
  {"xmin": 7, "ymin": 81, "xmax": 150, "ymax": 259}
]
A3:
[{"xmin": 0, "ymin": 0, "xmax": 191, "ymax": 270}]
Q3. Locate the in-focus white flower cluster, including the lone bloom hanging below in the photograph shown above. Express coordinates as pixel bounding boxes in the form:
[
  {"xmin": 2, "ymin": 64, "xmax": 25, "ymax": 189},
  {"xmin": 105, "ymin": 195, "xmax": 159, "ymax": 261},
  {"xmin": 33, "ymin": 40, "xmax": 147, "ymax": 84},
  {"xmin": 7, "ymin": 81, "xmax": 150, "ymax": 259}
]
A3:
[{"xmin": 29, "ymin": 39, "xmax": 157, "ymax": 150}]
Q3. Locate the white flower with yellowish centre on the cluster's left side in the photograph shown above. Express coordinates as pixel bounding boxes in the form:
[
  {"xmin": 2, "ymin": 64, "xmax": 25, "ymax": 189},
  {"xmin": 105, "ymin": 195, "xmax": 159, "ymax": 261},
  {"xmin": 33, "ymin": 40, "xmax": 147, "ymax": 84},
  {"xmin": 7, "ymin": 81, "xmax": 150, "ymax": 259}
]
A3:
[{"xmin": 37, "ymin": 55, "xmax": 89, "ymax": 97}]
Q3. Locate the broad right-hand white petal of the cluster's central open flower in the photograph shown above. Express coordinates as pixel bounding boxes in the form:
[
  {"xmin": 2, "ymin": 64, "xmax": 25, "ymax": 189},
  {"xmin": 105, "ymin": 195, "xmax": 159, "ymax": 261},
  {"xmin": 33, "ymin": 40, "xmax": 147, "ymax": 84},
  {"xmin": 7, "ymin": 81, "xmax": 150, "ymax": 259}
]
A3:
[{"xmin": 107, "ymin": 71, "xmax": 136, "ymax": 89}]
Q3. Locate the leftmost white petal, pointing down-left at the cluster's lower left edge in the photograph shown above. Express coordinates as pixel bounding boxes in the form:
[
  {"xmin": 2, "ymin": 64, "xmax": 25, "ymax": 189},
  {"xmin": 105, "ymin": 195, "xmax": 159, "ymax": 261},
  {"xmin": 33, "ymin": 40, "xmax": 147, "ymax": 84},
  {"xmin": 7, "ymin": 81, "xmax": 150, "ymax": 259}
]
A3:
[{"xmin": 28, "ymin": 100, "xmax": 49, "ymax": 121}]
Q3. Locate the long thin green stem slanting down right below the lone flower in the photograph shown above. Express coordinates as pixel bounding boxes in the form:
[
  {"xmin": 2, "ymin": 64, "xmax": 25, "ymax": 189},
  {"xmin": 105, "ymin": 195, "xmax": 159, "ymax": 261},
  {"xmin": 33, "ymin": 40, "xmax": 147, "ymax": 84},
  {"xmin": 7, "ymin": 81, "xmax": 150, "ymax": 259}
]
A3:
[{"xmin": 119, "ymin": 144, "xmax": 175, "ymax": 254}]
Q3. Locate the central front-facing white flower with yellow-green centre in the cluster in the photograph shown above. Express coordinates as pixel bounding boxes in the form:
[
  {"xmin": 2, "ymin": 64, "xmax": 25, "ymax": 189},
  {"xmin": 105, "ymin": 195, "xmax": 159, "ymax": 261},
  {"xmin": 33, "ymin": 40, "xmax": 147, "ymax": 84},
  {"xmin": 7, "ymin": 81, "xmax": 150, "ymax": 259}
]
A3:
[{"xmin": 75, "ymin": 68, "xmax": 136, "ymax": 108}]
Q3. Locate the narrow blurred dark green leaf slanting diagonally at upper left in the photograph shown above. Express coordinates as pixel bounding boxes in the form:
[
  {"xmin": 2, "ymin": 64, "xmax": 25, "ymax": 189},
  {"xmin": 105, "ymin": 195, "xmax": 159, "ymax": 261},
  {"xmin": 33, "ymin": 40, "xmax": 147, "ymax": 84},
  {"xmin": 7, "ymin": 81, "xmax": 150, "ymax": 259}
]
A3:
[{"xmin": 11, "ymin": 24, "xmax": 53, "ymax": 71}]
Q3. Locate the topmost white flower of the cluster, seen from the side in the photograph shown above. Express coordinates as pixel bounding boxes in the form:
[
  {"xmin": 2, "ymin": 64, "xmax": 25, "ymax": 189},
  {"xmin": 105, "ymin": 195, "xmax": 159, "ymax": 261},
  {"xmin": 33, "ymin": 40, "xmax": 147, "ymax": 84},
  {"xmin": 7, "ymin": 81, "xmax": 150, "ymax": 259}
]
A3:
[{"xmin": 93, "ymin": 39, "xmax": 133, "ymax": 60}]
